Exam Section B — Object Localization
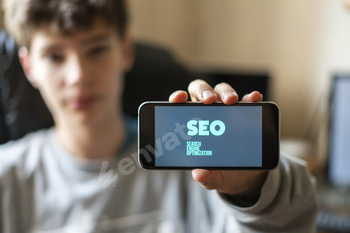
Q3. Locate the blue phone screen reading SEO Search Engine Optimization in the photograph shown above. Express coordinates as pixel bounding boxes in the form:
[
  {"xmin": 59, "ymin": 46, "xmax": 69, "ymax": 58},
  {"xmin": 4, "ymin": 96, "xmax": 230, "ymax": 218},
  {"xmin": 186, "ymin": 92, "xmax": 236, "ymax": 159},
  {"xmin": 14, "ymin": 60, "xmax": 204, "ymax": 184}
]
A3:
[{"xmin": 154, "ymin": 106, "xmax": 263, "ymax": 168}]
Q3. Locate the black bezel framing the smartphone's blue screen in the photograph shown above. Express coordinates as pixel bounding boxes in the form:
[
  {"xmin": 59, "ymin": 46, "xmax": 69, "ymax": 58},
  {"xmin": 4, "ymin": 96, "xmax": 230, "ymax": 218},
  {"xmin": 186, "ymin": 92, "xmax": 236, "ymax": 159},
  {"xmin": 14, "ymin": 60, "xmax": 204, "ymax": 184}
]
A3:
[{"xmin": 138, "ymin": 101, "xmax": 280, "ymax": 170}]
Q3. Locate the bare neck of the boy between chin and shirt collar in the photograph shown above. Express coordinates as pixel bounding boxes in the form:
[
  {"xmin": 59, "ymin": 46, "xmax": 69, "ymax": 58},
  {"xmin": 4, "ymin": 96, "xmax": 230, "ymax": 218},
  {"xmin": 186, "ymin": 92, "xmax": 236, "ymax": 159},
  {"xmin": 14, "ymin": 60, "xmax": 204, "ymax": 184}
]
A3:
[{"xmin": 55, "ymin": 111, "xmax": 126, "ymax": 159}]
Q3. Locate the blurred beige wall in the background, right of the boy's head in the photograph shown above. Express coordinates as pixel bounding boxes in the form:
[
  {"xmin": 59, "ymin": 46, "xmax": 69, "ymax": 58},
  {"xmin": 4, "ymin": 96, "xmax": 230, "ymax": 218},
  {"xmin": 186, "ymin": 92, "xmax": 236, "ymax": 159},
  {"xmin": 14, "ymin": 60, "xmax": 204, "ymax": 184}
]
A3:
[{"xmin": 0, "ymin": 0, "xmax": 350, "ymax": 231}]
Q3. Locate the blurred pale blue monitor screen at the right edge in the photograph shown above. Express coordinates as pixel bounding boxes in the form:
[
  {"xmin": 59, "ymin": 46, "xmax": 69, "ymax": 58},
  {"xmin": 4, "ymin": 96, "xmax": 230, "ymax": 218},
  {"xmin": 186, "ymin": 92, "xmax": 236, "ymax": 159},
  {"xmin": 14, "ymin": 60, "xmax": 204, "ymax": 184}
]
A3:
[{"xmin": 328, "ymin": 74, "xmax": 350, "ymax": 186}]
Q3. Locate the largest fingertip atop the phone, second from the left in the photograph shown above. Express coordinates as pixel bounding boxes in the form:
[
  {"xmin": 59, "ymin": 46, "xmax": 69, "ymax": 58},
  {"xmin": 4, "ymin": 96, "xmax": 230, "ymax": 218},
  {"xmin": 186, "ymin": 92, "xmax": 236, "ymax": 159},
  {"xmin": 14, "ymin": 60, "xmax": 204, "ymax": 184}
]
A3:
[{"xmin": 188, "ymin": 79, "xmax": 217, "ymax": 104}]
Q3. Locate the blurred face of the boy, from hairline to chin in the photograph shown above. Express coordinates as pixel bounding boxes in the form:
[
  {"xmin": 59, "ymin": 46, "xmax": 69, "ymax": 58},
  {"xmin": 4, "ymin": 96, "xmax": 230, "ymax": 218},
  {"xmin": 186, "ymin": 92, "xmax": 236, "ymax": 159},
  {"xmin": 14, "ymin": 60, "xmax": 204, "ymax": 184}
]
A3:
[{"xmin": 20, "ymin": 19, "xmax": 132, "ymax": 123}]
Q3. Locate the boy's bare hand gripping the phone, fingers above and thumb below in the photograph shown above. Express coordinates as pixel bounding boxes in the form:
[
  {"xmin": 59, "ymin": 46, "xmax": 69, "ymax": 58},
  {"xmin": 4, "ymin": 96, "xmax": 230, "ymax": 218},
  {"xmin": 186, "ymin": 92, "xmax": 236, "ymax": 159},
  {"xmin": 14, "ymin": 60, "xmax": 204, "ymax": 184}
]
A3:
[{"xmin": 138, "ymin": 80, "xmax": 278, "ymax": 202}]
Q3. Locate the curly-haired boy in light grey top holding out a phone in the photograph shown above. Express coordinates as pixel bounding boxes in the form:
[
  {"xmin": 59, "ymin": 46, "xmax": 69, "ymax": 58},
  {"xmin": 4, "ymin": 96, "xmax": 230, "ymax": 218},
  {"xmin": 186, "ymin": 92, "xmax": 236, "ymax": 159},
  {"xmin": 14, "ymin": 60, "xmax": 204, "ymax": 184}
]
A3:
[{"xmin": 0, "ymin": 0, "xmax": 316, "ymax": 233}]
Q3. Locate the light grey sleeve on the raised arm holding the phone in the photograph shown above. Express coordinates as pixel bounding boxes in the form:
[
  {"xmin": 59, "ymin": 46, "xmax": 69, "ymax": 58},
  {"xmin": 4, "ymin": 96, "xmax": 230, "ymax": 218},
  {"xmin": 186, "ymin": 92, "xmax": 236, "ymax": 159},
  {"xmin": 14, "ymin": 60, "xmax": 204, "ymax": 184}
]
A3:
[{"xmin": 219, "ymin": 155, "xmax": 317, "ymax": 233}]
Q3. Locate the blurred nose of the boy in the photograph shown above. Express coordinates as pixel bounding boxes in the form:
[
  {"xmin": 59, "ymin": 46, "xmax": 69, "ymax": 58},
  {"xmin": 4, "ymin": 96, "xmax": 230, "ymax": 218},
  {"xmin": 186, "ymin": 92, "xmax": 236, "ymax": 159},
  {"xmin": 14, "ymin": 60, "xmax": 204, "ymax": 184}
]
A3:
[{"xmin": 66, "ymin": 56, "xmax": 91, "ymax": 86}]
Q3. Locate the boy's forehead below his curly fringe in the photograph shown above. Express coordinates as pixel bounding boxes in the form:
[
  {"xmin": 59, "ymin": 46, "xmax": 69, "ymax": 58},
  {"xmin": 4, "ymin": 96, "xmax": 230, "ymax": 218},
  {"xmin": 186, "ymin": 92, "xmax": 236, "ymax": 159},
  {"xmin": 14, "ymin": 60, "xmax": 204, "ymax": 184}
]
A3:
[{"xmin": 30, "ymin": 19, "xmax": 120, "ymax": 50}]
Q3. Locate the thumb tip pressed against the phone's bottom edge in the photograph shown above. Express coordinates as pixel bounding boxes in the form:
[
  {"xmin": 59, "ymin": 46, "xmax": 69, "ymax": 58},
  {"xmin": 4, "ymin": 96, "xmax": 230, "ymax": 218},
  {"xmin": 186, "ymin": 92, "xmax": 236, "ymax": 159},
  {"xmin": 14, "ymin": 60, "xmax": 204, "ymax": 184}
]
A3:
[{"xmin": 192, "ymin": 169, "xmax": 223, "ymax": 190}]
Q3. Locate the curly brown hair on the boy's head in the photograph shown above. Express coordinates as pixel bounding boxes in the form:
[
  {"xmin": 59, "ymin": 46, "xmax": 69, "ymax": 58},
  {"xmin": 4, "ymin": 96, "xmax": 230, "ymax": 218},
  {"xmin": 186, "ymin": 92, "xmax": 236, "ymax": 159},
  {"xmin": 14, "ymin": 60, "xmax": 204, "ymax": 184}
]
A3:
[{"xmin": 3, "ymin": 0, "xmax": 128, "ymax": 48}]
